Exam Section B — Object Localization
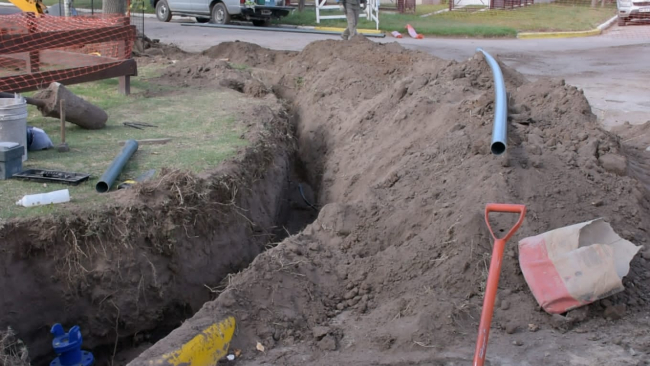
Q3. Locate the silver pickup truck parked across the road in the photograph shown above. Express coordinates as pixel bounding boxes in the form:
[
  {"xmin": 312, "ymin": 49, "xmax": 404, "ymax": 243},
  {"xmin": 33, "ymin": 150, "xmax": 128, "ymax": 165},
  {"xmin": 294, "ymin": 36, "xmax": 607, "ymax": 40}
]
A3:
[{"xmin": 149, "ymin": 0, "xmax": 294, "ymax": 26}]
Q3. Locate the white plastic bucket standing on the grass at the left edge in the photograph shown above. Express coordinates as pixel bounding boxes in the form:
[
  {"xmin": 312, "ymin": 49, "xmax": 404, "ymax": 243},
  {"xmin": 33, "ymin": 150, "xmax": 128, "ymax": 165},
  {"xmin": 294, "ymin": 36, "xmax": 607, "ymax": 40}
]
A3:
[{"xmin": 0, "ymin": 94, "xmax": 27, "ymax": 161}]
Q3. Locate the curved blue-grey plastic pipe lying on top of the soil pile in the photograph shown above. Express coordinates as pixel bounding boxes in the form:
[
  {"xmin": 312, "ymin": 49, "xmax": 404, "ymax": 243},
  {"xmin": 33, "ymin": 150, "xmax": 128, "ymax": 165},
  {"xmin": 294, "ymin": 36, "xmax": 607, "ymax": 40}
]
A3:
[{"xmin": 476, "ymin": 48, "xmax": 508, "ymax": 155}]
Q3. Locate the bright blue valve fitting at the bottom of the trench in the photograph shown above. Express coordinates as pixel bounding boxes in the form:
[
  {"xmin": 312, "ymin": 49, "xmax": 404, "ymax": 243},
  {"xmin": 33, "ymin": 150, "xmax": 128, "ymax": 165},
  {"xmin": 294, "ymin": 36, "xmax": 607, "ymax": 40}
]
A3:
[{"xmin": 50, "ymin": 323, "xmax": 95, "ymax": 366}]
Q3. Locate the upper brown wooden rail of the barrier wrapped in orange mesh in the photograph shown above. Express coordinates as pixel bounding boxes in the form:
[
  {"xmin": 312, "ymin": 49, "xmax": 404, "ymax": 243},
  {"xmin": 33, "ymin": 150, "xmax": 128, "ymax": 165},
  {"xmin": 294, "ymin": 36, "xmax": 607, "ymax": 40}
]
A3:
[{"xmin": 0, "ymin": 25, "xmax": 135, "ymax": 54}]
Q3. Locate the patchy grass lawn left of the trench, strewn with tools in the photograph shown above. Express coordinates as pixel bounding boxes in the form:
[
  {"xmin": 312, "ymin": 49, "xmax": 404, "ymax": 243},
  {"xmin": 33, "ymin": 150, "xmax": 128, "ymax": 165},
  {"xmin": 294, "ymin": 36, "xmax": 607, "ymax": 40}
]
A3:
[{"xmin": 0, "ymin": 66, "xmax": 254, "ymax": 219}]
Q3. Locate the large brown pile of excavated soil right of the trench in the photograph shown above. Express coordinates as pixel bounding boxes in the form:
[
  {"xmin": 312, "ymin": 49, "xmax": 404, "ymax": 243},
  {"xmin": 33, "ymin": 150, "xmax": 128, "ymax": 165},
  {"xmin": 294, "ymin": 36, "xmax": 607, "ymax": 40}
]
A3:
[{"xmin": 131, "ymin": 37, "xmax": 650, "ymax": 365}]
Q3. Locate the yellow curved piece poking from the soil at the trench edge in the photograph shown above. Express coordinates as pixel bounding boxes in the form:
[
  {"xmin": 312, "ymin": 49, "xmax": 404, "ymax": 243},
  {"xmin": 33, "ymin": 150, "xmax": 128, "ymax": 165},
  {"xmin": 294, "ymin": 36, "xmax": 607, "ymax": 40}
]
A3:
[{"xmin": 150, "ymin": 317, "xmax": 235, "ymax": 366}]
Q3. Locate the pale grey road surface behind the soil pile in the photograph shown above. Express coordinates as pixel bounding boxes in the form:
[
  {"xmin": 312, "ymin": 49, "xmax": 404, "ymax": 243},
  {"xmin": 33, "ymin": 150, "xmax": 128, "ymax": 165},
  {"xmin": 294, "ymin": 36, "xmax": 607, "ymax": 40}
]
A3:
[{"xmin": 145, "ymin": 19, "xmax": 650, "ymax": 132}]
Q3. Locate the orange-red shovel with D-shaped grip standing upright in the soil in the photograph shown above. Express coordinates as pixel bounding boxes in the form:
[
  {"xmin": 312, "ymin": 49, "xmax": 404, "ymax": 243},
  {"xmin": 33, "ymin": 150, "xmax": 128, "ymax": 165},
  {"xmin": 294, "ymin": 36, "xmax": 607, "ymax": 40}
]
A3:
[{"xmin": 473, "ymin": 203, "xmax": 526, "ymax": 366}]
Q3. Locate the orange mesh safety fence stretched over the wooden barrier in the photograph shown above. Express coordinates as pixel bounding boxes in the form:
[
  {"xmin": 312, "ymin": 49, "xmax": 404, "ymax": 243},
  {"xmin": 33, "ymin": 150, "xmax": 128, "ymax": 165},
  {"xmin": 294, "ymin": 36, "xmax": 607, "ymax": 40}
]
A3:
[{"xmin": 0, "ymin": 13, "xmax": 135, "ymax": 92}]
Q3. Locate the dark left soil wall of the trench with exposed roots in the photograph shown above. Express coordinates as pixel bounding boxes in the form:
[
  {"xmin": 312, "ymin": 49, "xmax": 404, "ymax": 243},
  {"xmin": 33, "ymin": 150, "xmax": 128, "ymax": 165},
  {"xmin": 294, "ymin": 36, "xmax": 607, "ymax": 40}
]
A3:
[{"xmin": 0, "ymin": 100, "xmax": 306, "ymax": 365}]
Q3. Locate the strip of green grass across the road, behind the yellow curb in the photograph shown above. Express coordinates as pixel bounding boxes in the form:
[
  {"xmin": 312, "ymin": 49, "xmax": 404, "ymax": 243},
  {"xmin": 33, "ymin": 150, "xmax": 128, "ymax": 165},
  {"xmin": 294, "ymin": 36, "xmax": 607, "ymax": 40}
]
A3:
[{"xmin": 277, "ymin": 4, "xmax": 616, "ymax": 37}]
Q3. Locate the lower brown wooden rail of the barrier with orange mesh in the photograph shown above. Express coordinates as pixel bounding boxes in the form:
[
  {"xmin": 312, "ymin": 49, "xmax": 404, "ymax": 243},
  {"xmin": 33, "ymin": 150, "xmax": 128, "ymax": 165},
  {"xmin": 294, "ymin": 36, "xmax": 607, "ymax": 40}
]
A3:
[{"xmin": 0, "ymin": 59, "xmax": 138, "ymax": 93}]
